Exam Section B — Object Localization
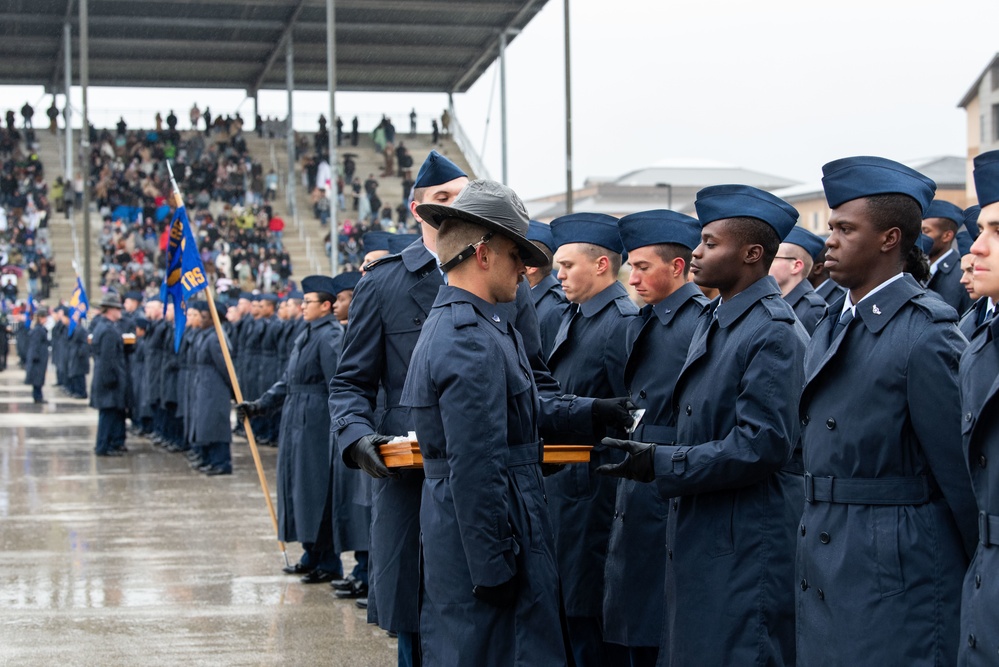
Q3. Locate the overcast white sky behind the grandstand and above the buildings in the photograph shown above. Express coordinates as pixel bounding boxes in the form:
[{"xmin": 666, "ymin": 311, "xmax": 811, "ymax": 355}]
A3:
[{"xmin": 0, "ymin": 0, "xmax": 999, "ymax": 199}]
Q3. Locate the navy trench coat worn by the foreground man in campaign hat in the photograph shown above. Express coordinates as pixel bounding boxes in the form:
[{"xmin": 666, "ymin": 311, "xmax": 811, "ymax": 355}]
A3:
[{"xmin": 401, "ymin": 286, "xmax": 566, "ymax": 667}]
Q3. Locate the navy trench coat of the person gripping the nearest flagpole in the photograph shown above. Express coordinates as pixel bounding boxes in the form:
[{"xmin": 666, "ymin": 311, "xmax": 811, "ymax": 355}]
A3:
[{"xmin": 258, "ymin": 315, "xmax": 343, "ymax": 543}]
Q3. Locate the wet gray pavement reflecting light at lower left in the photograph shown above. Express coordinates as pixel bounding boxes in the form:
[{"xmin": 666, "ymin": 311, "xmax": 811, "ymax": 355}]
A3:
[{"xmin": 0, "ymin": 368, "xmax": 396, "ymax": 666}]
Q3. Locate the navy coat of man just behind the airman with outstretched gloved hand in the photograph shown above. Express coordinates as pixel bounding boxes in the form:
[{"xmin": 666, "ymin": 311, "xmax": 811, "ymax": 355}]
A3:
[{"xmin": 603, "ymin": 283, "xmax": 709, "ymax": 647}]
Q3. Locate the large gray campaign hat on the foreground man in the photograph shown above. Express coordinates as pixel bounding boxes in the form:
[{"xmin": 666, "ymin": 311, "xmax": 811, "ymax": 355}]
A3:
[{"xmin": 416, "ymin": 180, "xmax": 548, "ymax": 266}]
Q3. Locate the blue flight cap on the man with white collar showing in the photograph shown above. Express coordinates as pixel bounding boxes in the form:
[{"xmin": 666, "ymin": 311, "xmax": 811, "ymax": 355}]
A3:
[{"xmin": 822, "ymin": 155, "xmax": 937, "ymax": 212}]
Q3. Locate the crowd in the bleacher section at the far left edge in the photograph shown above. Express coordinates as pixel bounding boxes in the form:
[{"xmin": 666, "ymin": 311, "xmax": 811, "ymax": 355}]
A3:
[{"xmin": 0, "ymin": 115, "xmax": 56, "ymax": 305}]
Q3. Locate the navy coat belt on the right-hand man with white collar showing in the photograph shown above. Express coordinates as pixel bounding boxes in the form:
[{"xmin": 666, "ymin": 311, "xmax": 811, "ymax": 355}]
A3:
[{"xmin": 805, "ymin": 472, "xmax": 932, "ymax": 505}]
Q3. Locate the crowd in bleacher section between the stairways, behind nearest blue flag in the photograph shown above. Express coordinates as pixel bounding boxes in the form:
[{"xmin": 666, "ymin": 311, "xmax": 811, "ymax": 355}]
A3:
[{"xmin": 89, "ymin": 111, "xmax": 292, "ymax": 294}]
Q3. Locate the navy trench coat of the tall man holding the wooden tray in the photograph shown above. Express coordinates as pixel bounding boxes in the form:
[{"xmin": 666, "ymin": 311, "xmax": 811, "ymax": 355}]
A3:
[{"xmin": 329, "ymin": 239, "xmax": 593, "ymax": 633}]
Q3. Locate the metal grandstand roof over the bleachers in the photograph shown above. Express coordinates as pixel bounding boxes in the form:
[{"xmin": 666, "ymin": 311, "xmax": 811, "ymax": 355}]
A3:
[{"xmin": 0, "ymin": 0, "xmax": 547, "ymax": 94}]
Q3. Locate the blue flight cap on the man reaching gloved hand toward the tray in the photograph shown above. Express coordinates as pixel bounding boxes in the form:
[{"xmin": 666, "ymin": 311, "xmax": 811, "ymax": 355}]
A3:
[{"xmin": 694, "ymin": 185, "xmax": 798, "ymax": 241}]
